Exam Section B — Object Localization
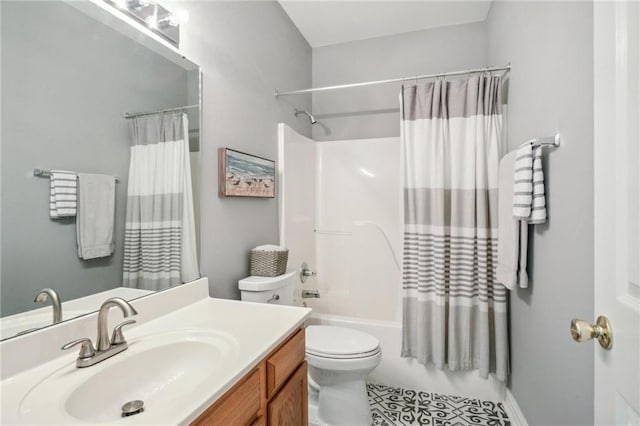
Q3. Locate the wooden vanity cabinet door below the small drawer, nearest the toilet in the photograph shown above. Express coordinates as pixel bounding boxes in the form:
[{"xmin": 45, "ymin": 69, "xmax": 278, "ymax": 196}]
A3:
[{"xmin": 267, "ymin": 361, "xmax": 308, "ymax": 426}]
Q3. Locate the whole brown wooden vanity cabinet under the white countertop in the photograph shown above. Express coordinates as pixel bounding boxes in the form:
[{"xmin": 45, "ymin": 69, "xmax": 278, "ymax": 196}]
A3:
[{"xmin": 191, "ymin": 328, "xmax": 308, "ymax": 426}]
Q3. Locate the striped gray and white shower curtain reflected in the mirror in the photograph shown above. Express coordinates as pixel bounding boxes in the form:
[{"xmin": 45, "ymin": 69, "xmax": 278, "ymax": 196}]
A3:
[{"xmin": 123, "ymin": 113, "xmax": 200, "ymax": 290}]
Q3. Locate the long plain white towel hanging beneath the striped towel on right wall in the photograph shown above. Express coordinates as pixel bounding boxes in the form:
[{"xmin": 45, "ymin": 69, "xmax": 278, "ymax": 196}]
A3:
[{"xmin": 496, "ymin": 151, "xmax": 529, "ymax": 290}]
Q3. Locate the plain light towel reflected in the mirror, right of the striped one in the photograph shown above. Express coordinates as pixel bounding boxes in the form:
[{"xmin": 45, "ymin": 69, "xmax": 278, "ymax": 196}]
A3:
[{"xmin": 76, "ymin": 173, "xmax": 116, "ymax": 260}]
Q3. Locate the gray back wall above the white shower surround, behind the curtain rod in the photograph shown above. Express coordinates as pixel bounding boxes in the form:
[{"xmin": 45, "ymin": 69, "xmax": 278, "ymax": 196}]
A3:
[{"xmin": 313, "ymin": 22, "xmax": 487, "ymax": 140}]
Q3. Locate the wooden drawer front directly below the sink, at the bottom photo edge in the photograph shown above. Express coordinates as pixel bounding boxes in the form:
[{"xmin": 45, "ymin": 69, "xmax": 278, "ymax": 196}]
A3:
[{"xmin": 191, "ymin": 369, "xmax": 260, "ymax": 426}]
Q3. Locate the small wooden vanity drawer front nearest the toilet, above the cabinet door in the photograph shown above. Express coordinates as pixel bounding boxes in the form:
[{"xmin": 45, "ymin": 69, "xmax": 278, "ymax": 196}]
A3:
[{"xmin": 267, "ymin": 328, "xmax": 304, "ymax": 398}]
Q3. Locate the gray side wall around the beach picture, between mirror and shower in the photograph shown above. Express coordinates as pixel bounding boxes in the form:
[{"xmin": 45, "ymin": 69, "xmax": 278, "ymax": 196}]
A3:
[{"xmin": 177, "ymin": 1, "xmax": 311, "ymax": 298}]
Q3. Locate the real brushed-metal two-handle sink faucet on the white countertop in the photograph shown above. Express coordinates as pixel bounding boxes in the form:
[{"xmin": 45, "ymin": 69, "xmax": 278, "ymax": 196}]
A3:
[{"xmin": 62, "ymin": 297, "xmax": 138, "ymax": 368}]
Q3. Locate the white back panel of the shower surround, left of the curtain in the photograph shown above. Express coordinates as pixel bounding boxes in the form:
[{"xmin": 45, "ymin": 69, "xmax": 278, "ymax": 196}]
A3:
[{"xmin": 313, "ymin": 137, "xmax": 402, "ymax": 320}]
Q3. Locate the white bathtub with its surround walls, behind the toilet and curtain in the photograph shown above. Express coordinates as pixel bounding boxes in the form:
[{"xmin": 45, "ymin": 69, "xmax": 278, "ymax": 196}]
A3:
[{"xmin": 278, "ymin": 124, "xmax": 505, "ymax": 401}]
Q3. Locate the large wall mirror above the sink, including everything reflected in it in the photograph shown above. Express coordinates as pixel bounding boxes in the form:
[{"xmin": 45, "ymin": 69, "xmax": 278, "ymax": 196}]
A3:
[{"xmin": 0, "ymin": 1, "xmax": 200, "ymax": 339}]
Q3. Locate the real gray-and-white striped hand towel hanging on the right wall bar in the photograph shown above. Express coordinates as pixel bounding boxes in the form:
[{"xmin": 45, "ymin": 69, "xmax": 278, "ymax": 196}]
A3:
[{"xmin": 513, "ymin": 143, "xmax": 547, "ymax": 224}]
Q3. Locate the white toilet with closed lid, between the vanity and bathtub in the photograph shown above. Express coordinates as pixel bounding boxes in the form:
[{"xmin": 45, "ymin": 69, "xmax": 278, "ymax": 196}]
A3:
[{"xmin": 238, "ymin": 271, "xmax": 382, "ymax": 426}]
